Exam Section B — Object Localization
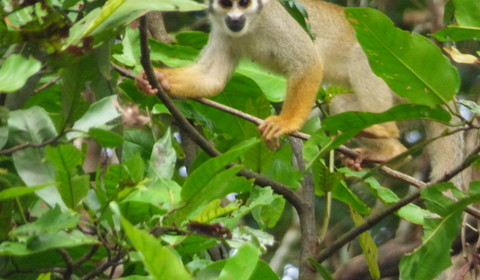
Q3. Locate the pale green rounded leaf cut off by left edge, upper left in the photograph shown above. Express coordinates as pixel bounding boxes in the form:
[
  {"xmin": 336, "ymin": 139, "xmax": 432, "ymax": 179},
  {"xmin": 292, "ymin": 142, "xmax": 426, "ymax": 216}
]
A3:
[{"xmin": 0, "ymin": 54, "xmax": 42, "ymax": 92}]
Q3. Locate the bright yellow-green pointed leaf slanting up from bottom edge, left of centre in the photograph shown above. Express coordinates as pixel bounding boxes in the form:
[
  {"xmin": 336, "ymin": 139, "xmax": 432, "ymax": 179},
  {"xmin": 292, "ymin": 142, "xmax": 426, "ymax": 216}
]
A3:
[{"xmin": 122, "ymin": 218, "xmax": 191, "ymax": 280}]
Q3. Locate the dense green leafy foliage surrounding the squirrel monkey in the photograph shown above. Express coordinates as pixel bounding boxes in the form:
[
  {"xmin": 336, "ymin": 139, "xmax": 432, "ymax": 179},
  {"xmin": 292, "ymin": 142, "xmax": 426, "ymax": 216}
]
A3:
[{"xmin": 0, "ymin": 0, "xmax": 480, "ymax": 280}]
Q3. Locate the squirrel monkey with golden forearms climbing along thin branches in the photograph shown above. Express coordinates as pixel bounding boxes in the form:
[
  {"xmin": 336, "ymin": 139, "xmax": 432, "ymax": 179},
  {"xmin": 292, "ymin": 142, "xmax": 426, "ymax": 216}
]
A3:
[{"xmin": 137, "ymin": 0, "xmax": 463, "ymax": 186}]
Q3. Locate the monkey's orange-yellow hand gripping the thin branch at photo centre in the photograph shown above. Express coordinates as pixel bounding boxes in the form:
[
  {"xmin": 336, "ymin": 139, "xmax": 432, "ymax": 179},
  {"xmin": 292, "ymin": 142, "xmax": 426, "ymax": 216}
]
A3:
[{"xmin": 258, "ymin": 116, "xmax": 300, "ymax": 150}]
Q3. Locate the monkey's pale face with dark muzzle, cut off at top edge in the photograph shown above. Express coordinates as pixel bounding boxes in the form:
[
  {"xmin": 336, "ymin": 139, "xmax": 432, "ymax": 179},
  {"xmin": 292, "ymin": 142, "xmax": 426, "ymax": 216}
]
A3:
[{"xmin": 209, "ymin": 0, "xmax": 268, "ymax": 36}]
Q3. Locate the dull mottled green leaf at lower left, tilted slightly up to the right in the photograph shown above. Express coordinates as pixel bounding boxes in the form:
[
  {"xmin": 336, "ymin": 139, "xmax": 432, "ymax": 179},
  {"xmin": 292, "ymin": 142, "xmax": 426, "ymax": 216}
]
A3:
[{"xmin": 10, "ymin": 206, "xmax": 80, "ymax": 241}]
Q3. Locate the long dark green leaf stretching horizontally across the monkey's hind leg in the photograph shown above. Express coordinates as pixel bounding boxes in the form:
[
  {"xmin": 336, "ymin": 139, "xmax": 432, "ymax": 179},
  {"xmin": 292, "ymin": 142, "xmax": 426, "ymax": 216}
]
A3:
[{"xmin": 323, "ymin": 104, "xmax": 451, "ymax": 148}]
